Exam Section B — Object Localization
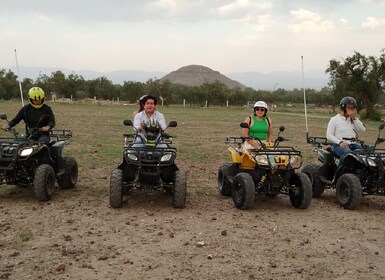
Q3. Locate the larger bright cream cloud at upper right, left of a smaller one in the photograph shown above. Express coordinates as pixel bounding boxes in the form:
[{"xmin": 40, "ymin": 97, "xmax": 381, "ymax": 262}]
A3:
[{"xmin": 288, "ymin": 9, "xmax": 335, "ymax": 33}]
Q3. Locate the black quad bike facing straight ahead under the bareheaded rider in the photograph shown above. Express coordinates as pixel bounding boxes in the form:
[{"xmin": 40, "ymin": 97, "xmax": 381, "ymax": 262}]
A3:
[{"xmin": 109, "ymin": 120, "xmax": 187, "ymax": 208}]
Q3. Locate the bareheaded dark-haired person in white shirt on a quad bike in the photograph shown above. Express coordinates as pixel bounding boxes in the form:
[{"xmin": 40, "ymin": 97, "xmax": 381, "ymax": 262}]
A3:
[{"xmin": 134, "ymin": 95, "xmax": 167, "ymax": 141}]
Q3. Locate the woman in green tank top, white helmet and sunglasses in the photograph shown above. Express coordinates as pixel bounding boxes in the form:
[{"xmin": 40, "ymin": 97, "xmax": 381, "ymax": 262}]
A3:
[{"xmin": 242, "ymin": 101, "xmax": 273, "ymax": 149}]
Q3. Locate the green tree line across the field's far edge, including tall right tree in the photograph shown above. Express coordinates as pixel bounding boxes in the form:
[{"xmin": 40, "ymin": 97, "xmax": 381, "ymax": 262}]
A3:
[{"xmin": 0, "ymin": 52, "xmax": 385, "ymax": 115}]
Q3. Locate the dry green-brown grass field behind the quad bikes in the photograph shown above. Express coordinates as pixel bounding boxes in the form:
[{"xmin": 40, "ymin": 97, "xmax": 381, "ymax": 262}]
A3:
[{"xmin": 0, "ymin": 102, "xmax": 378, "ymax": 195}]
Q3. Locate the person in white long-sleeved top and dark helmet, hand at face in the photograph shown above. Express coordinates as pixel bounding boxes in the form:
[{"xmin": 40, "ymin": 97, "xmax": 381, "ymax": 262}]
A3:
[{"xmin": 326, "ymin": 96, "xmax": 366, "ymax": 174}]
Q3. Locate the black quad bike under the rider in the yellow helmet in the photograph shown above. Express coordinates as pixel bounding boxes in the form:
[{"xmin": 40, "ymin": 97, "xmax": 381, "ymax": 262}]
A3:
[{"xmin": 0, "ymin": 114, "xmax": 78, "ymax": 201}]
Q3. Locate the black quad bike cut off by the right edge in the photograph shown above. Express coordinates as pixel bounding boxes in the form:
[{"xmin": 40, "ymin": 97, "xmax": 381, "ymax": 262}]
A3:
[{"xmin": 302, "ymin": 124, "xmax": 385, "ymax": 210}]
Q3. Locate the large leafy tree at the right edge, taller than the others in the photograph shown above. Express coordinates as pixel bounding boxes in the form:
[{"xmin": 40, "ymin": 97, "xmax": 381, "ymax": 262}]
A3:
[{"xmin": 326, "ymin": 51, "xmax": 385, "ymax": 119}]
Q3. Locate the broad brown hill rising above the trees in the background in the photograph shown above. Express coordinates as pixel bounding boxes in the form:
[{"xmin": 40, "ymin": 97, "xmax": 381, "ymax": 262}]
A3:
[{"xmin": 161, "ymin": 65, "xmax": 246, "ymax": 89}]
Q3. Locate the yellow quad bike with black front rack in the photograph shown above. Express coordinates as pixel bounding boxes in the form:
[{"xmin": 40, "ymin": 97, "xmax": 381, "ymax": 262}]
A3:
[{"xmin": 218, "ymin": 123, "xmax": 312, "ymax": 209}]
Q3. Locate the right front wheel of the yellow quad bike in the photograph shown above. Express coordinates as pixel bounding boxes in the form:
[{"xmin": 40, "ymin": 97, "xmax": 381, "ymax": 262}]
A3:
[{"xmin": 289, "ymin": 173, "xmax": 313, "ymax": 209}]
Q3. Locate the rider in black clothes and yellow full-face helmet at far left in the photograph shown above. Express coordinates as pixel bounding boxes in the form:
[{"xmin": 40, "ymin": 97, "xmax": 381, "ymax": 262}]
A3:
[{"xmin": 2, "ymin": 87, "xmax": 55, "ymax": 144}]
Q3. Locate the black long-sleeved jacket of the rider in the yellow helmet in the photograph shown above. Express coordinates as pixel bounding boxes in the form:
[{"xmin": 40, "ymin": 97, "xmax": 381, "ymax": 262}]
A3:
[{"xmin": 9, "ymin": 104, "xmax": 55, "ymax": 134}]
